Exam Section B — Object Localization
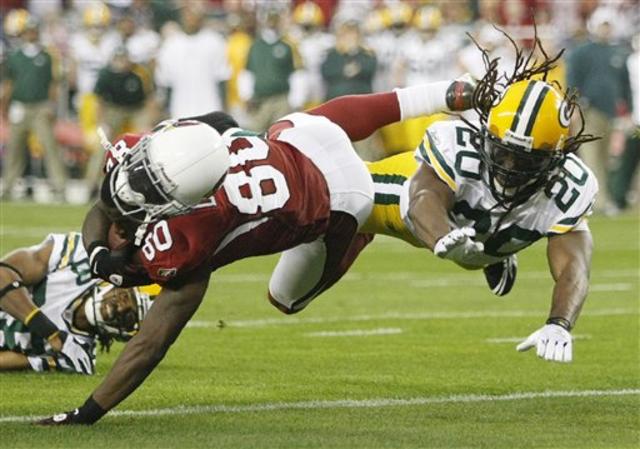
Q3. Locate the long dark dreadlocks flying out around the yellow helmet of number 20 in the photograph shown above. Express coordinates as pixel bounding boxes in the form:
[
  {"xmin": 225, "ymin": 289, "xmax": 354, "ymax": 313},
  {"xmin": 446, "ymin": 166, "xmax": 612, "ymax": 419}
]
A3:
[{"xmin": 459, "ymin": 22, "xmax": 601, "ymax": 153}]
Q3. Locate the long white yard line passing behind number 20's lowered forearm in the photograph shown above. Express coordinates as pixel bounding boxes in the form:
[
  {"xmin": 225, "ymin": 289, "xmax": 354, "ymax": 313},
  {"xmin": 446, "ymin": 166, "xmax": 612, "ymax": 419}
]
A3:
[{"xmin": 187, "ymin": 308, "xmax": 638, "ymax": 328}]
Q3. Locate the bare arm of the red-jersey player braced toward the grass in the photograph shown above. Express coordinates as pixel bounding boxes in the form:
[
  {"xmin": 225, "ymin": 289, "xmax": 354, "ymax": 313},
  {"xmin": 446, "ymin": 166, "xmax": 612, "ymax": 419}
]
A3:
[{"xmin": 92, "ymin": 275, "xmax": 208, "ymax": 410}]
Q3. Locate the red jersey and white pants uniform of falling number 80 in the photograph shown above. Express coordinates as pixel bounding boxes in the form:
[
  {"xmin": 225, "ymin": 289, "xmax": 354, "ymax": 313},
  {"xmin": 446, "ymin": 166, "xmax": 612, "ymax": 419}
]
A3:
[{"xmin": 106, "ymin": 92, "xmax": 416, "ymax": 313}]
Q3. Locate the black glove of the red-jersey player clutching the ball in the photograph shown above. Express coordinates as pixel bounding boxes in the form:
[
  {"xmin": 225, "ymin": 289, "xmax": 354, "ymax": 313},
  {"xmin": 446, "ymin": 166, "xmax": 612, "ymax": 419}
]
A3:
[{"xmin": 89, "ymin": 241, "xmax": 142, "ymax": 288}]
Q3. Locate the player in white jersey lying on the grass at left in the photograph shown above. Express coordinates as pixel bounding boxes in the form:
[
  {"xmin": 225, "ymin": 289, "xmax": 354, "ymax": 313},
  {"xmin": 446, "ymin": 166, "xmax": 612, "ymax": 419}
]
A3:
[{"xmin": 0, "ymin": 232, "xmax": 150, "ymax": 374}]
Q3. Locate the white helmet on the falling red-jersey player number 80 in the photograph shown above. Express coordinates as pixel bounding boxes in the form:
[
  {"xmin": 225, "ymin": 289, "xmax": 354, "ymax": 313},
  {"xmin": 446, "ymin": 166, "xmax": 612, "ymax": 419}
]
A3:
[{"xmin": 109, "ymin": 120, "xmax": 229, "ymax": 222}]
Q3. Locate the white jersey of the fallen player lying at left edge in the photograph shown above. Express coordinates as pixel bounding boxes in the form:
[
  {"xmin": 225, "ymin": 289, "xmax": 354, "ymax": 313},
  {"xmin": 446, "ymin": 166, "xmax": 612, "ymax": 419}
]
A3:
[{"xmin": 0, "ymin": 232, "xmax": 98, "ymax": 371}]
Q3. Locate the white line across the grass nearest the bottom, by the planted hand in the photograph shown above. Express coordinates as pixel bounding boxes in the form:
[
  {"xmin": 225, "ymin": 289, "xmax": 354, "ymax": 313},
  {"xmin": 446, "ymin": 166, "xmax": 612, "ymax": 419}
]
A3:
[{"xmin": 0, "ymin": 388, "xmax": 640, "ymax": 423}]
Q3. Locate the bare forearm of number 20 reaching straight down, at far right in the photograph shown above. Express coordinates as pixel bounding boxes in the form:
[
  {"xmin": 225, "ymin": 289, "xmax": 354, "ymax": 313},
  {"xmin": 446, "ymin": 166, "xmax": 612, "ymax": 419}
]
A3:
[{"xmin": 547, "ymin": 230, "xmax": 593, "ymax": 326}]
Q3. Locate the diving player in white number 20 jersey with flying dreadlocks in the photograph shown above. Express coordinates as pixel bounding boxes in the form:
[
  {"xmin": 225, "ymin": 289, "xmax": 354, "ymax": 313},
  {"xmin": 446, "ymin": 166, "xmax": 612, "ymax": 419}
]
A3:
[{"xmin": 362, "ymin": 35, "xmax": 598, "ymax": 362}]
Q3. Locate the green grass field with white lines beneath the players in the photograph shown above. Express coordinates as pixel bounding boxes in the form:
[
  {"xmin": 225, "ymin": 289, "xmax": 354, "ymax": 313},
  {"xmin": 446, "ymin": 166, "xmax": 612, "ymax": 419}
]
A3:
[{"xmin": 0, "ymin": 203, "xmax": 640, "ymax": 449}]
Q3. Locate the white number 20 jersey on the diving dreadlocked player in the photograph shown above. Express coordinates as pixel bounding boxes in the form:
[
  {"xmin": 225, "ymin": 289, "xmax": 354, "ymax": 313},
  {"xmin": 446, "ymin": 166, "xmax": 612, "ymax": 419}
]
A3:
[{"xmin": 403, "ymin": 120, "xmax": 598, "ymax": 264}]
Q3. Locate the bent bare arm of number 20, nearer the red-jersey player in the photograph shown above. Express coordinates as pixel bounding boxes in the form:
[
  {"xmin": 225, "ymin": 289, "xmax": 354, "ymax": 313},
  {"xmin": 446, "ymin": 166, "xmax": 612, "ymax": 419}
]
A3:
[{"xmin": 409, "ymin": 164, "xmax": 453, "ymax": 251}]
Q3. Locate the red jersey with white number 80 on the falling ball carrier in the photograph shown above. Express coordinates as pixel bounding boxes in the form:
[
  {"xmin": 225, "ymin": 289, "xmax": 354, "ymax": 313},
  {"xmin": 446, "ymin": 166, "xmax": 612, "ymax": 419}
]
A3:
[{"xmin": 107, "ymin": 123, "xmax": 330, "ymax": 283}]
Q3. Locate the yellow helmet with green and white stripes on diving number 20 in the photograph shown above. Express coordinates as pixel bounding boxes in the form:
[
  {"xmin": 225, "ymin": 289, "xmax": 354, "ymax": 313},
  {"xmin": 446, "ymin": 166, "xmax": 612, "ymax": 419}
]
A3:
[{"xmin": 479, "ymin": 80, "xmax": 570, "ymax": 202}]
